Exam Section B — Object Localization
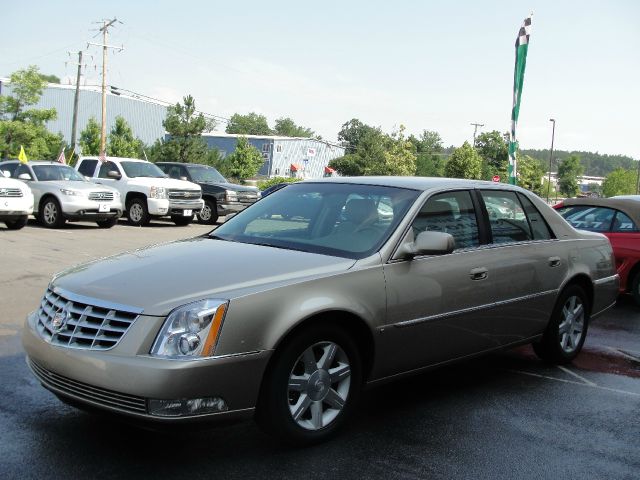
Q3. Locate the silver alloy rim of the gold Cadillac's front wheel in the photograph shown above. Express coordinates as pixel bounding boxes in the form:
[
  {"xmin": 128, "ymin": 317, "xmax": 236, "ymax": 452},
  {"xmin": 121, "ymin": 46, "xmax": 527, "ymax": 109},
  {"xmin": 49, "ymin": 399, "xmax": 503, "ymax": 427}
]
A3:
[{"xmin": 287, "ymin": 342, "xmax": 351, "ymax": 430}]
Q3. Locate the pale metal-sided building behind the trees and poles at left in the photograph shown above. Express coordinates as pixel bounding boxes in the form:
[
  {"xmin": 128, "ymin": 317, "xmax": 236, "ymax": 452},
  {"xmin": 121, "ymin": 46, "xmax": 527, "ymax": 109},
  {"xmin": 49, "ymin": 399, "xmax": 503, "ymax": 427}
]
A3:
[{"xmin": 0, "ymin": 81, "xmax": 167, "ymax": 144}]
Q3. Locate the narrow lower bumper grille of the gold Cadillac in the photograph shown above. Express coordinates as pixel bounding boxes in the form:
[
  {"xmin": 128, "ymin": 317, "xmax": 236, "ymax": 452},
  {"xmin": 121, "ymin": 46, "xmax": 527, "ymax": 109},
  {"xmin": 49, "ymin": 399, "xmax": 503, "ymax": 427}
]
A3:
[{"xmin": 27, "ymin": 359, "xmax": 147, "ymax": 413}]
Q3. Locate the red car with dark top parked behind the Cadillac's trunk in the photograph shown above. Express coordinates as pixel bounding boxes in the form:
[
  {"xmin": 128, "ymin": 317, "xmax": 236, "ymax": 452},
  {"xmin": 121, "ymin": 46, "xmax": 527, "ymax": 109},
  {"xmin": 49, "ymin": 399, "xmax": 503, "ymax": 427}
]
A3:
[{"xmin": 553, "ymin": 198, "xmax": 640, "ymax": 305}]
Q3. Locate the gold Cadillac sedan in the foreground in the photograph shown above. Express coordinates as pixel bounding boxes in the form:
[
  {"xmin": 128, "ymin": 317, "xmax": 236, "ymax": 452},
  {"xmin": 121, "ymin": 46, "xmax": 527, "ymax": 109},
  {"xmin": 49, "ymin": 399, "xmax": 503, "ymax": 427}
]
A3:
[{"xmin": 23, "ymin": 177, "xmax": 618, "ymax": 444}]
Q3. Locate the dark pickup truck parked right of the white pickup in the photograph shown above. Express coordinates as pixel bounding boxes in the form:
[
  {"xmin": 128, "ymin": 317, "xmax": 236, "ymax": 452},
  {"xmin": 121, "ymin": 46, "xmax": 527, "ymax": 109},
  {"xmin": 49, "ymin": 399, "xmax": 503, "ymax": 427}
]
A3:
[{"xmin": 156, "ymin": 162, "xmax": 260, "ymax": 224}]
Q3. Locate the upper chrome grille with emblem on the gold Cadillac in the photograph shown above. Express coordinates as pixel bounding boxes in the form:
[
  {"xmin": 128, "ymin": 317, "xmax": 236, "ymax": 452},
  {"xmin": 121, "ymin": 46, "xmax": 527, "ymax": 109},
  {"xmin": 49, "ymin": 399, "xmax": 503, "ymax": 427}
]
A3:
[{"xmin": 37, "ymin": 289, "xmax": 138, "ymax": 350}]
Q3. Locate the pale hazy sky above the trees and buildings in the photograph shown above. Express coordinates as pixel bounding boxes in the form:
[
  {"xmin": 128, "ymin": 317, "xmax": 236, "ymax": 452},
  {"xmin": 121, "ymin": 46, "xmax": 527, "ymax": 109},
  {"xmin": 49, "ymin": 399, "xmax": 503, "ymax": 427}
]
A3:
[{"xmin": 0, "ymin": 0, "xmax": 640, "ymax": 159}]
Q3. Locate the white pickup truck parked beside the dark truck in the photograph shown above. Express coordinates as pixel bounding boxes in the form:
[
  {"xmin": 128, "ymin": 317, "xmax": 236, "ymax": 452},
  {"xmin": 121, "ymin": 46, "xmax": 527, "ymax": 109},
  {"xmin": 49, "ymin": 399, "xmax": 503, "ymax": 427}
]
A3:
[{"xmin": 76, "ymin": 157, "xmax": 204, "ymax": 226}]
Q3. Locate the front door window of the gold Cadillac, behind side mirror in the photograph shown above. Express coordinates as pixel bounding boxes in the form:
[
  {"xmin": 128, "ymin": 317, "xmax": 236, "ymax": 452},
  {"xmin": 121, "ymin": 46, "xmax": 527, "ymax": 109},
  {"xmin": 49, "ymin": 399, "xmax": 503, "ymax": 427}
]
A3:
[{"xmin": 411, "ymin": 191, "xmax": 480, "ymax": 249}]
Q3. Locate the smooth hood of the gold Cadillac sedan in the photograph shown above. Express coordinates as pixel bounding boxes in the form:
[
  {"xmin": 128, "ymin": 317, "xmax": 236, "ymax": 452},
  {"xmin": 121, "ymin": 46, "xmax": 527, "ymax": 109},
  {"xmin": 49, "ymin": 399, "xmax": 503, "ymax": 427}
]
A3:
[{"xmin": 53, "ymin": 237, "xmax": 355, "ymax": 315}]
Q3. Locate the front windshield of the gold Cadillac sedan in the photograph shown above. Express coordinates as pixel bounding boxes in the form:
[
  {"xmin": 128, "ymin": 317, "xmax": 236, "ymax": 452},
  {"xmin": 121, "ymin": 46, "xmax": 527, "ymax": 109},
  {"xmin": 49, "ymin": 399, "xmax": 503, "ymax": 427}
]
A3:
[{"xmin": 209, "ymin": 182, "xmax": 420, "ymax": 259}]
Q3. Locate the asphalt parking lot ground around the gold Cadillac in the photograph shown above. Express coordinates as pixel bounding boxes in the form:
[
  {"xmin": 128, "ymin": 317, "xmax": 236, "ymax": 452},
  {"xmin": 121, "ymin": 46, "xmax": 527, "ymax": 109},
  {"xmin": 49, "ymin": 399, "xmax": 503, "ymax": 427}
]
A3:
[{"xmin": 0, "ymin": 221, "xmax": 640, "ymax": 479}]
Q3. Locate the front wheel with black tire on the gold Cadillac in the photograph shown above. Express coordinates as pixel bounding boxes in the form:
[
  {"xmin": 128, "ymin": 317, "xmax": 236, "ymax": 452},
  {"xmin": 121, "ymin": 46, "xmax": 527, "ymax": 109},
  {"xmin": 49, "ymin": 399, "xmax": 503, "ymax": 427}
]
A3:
[{"xmin": 256, "ymin": 324, "xmax": 362, "ymax": 445}]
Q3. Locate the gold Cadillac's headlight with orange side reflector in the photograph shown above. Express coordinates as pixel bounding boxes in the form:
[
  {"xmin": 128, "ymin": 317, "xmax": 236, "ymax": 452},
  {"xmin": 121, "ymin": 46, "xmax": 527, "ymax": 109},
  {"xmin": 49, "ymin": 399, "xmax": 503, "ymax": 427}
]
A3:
[{"xmin": 151, "ymin": 299, "xmax": 229, "ymax": 359}]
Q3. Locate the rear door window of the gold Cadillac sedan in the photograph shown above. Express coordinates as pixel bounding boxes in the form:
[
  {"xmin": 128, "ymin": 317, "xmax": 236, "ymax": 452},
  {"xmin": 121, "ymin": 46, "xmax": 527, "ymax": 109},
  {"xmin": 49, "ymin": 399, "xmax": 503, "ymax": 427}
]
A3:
[{"xmin": 480, "ymin": 190, "xmax": 534, "ymax": 243}]
